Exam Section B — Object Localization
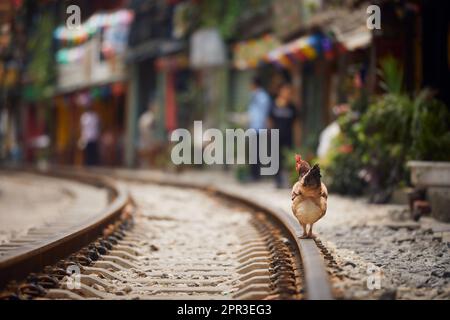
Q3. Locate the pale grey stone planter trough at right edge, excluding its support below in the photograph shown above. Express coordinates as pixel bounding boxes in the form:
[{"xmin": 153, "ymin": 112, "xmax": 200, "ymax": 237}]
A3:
[{"xmin": 408, "ymin": 161, "xmax": 450, "ymax": 188}]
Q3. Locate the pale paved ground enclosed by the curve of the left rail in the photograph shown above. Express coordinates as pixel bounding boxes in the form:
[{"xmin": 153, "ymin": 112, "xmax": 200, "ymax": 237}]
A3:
[{"xmin": 0, "ymin": 171, "xmax": 107, "ymax": 244}]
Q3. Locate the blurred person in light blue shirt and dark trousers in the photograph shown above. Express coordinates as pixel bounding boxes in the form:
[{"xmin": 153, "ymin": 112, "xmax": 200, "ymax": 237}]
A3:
[{"xmin": 248, "ymin": 76, "xmax": 271, "ymax": 180}]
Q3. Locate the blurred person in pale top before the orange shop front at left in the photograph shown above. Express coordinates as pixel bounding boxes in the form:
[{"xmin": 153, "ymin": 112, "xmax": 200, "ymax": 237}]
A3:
[{"xmin": 80, "ymin": 105, "xmax": 100, "ymax": 166}]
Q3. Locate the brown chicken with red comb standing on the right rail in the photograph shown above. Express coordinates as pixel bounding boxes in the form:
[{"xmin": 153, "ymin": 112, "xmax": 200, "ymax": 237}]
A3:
[{"xmin": 291, "ymin": 155, "xmax": 328, "ymax": 239}]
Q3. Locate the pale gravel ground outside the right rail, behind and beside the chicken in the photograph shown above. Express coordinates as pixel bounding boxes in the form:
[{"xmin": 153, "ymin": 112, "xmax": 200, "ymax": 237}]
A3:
[{"xmin": 110, "ymin": 171, "xmax": 450, "ymax": 299}]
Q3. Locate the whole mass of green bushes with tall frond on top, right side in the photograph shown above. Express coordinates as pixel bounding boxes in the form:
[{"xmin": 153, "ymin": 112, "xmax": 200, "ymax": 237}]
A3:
[{"xmin": 322, "ymin": 57, "xmax": 450, "ymax": 202}]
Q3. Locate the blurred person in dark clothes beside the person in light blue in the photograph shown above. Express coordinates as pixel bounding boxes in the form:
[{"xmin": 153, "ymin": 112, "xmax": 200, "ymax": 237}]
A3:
[{"xmin": 270, "ymin": 83, "xmax": 297, "ymax": 188}]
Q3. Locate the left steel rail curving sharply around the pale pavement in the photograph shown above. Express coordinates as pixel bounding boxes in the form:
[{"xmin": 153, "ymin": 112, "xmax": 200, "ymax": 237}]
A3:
[{"xmin": 0, "ymin": 168, "xmax": 130, "ymax": 288}]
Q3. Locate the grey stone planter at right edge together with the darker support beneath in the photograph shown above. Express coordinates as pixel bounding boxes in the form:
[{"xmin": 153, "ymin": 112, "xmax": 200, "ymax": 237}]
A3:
[{"xmin": 408, "ymin": 161, "xmax": 450, "ymax": 222}]
